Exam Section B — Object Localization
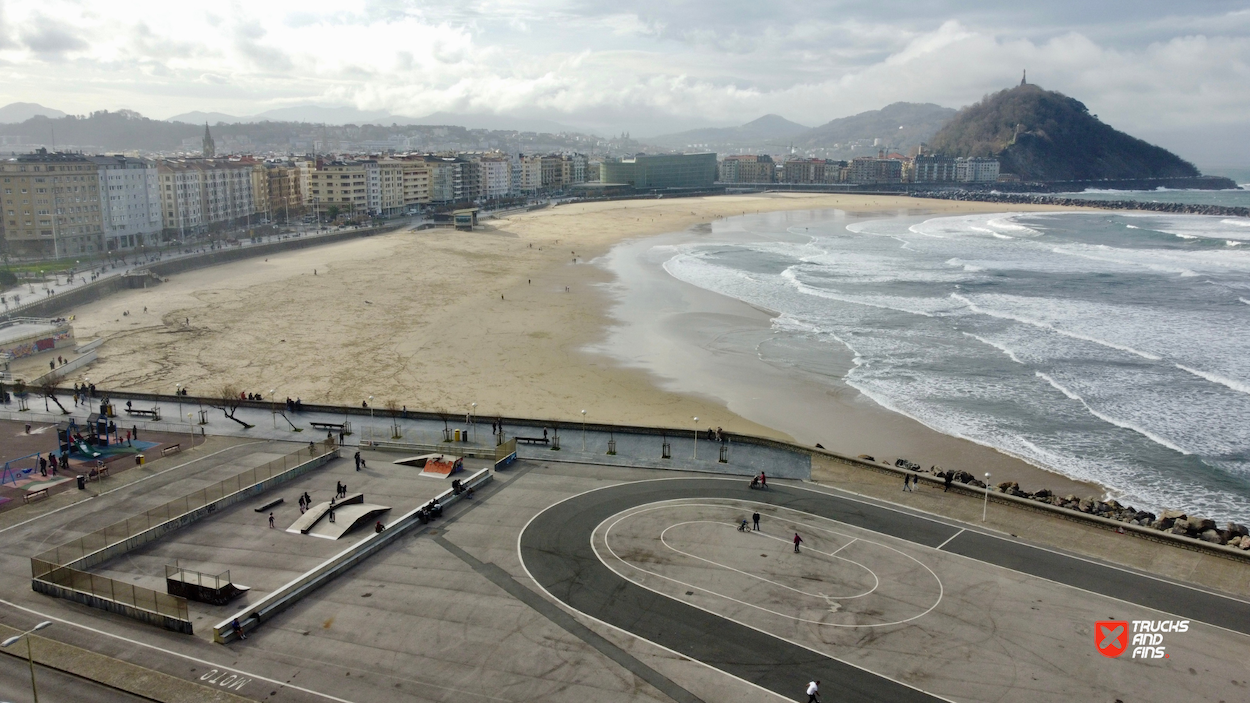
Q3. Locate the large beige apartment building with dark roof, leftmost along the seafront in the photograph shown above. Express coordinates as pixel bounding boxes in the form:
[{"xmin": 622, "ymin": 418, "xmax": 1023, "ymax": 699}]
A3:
[{"xmin": 0, "ymin": 149, "xmax": 104, "ymax": 258}]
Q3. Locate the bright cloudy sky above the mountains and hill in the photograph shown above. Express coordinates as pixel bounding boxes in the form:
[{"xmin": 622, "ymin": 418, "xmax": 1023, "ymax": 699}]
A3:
[{"xmin": 0, "ymin": 0, "xmax": 1250, "ymax": 163}]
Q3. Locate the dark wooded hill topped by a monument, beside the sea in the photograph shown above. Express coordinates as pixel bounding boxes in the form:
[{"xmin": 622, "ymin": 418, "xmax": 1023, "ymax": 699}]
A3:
[{"xmin": 930, "ymin": 84, "xmax": 1201, "ymax": 180}]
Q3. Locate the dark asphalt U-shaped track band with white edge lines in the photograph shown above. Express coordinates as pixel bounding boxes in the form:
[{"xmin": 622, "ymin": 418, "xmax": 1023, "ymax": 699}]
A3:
[{"xmin": 519, "ymin": 478, "xmax": 1250, "ymax": 703}]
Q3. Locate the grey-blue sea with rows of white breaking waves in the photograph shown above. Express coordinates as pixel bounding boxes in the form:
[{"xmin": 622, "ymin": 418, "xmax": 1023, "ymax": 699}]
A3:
[{"xmin": 664, "ymin": 207, "xmax": 1250, "ymax": 522}]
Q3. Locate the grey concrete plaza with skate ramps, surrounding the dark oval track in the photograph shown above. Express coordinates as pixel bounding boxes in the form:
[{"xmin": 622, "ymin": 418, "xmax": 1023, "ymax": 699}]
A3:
[{"xmin": 0, "ymin": 397, "xmax": 1250, "ymax": 703}]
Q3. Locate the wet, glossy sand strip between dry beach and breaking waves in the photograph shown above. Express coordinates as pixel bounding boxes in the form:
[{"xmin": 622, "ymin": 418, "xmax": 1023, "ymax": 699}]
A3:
[{"xmin": 591, "ymin": 205, "xmax": 1109, "ymax": 499}]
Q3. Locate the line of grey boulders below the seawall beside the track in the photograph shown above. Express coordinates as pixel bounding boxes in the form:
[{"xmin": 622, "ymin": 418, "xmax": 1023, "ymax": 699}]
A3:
[{"xmin": 894, "ymin": 459, "xmax": 1250, "ymax": 550}]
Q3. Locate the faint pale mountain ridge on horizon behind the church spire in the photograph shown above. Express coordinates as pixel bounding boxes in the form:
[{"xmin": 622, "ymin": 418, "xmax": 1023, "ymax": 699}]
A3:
[{"xmin": 165, "ymin": 105, "xmax": 584, "ymax": 134}]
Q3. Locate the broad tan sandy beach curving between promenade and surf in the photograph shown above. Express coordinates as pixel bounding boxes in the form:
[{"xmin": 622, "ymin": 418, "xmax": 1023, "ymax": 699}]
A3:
[{"xmin": 63, "ymin": 194, "xmax": 1098, "ymax": 494}]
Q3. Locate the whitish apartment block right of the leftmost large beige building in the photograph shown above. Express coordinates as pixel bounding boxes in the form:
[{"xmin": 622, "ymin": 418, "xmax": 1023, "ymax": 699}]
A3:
[{"xmin": 89, "ymin": 156, "xmax": 161, "ymax": 251}]
